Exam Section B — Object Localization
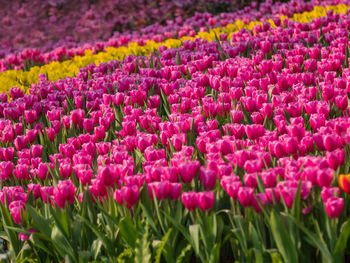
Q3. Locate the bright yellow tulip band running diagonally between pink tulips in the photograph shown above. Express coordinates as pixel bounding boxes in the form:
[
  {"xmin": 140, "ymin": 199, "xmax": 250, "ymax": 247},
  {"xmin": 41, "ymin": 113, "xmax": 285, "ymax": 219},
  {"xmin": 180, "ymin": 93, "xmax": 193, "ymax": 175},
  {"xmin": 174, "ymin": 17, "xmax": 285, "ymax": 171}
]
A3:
[{"xmin": 0, "ymin": 4, "xmax": 348, "ymax": 97}]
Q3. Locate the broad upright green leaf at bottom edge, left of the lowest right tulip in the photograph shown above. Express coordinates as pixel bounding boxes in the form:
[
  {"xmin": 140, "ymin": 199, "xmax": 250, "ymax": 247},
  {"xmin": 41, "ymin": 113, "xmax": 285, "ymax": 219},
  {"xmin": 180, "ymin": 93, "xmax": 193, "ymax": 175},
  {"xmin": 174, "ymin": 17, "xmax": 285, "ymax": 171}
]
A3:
[{"xmin": 270, "ymin": 211, "xmax": 299, "ymax": 263}]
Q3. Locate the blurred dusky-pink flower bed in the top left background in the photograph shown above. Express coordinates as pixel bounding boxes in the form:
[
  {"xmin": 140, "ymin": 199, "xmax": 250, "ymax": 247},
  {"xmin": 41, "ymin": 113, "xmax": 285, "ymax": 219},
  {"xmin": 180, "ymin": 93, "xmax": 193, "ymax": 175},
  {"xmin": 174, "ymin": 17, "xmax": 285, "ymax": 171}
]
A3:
[{"xmin": 0, "ymin": 0, "xmax": 249, "ymax": 58}]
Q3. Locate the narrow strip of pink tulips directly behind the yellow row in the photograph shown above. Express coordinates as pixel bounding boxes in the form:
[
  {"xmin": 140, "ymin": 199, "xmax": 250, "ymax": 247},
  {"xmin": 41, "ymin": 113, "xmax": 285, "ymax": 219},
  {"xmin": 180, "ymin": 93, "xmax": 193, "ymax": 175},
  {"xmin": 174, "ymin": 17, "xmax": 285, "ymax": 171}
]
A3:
[{"xmin": 0, "ymin": 1, "xmax": 314, "ymax": 72}]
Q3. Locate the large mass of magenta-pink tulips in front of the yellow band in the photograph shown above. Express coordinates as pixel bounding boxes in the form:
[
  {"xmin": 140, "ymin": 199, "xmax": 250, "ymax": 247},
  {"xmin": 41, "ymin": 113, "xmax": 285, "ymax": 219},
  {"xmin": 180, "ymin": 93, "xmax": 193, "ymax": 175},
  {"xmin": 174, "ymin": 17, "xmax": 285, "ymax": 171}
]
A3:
[{"xmin": 0, "ymin": 1, "xmax": 350, "ymax": 262}]
